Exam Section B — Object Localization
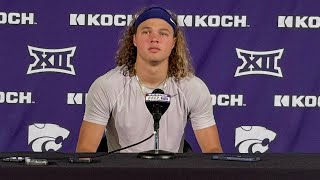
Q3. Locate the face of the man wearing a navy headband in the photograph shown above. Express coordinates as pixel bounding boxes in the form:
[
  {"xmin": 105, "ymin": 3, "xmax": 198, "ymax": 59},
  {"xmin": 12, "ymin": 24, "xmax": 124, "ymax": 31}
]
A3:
[{"xmin": 133, "ymin": 18, "xmax": 176, "ymax": 65}]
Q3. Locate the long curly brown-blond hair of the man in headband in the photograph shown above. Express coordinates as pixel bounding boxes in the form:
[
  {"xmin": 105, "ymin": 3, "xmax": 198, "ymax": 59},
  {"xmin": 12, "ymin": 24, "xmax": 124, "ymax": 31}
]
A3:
[{"xmin": 116, "ymin": 8, "xmax": 194, "ymax": 81}]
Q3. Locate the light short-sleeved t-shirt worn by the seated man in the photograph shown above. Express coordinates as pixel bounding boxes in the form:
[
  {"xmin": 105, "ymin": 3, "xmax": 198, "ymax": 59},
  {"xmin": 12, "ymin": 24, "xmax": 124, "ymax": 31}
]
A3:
[{"xmin": 84, "ymin": 67, "xmax": 215, "ymax": 152}]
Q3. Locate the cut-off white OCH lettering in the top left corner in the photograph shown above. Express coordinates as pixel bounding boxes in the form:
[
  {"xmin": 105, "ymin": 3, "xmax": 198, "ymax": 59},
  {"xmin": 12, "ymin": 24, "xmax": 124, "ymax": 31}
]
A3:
[{"xmin": 0, "ymin": 12, "xmax": 37, "ymax": 25}]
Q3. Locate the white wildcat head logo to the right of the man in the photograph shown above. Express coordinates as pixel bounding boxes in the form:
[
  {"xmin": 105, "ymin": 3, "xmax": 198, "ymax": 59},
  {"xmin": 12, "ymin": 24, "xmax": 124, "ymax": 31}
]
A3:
[{"xmin": 235, "ymin": 126, "xmax": 277, "ymax": 153}]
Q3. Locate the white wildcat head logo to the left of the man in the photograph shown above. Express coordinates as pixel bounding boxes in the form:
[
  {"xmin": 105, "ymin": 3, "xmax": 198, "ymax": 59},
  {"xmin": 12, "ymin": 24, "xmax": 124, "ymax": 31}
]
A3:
[{"xmin": 28, "ymin": 124, "xmax": 70, "ymax": 152}]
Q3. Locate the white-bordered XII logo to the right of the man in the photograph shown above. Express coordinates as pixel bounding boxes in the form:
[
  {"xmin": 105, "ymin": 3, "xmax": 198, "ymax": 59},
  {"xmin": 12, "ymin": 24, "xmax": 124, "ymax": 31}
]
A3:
[{"xmin": 234, "ymin": 48, "xmax": 283, "ymax": 77}]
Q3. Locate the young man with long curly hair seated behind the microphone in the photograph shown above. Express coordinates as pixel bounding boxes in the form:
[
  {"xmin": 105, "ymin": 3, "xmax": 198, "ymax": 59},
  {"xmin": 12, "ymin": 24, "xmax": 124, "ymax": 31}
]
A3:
[{"xmin": 76, "ymin": 7, "xmax": 222, "ymax": 153}]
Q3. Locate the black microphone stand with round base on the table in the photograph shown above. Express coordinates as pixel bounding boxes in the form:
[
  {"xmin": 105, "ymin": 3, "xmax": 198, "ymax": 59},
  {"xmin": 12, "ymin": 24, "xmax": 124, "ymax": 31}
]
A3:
[{"xmin": 137, "ymin": 113, "xmax": 175, "ymax": 159}]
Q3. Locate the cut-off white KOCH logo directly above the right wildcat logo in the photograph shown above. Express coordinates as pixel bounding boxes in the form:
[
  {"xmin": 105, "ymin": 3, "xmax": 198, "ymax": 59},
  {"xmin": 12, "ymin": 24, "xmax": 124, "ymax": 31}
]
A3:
[{"xmin": 274, "ymin": 95, "xmax": 320, "ymax": 107}]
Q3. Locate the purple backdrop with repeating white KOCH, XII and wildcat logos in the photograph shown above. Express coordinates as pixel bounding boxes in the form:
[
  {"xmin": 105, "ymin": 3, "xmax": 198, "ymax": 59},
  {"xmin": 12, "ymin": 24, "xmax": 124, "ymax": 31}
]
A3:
[{"xmin": 0, "ymin": 0, "xmax": 320, "ymax": 153}]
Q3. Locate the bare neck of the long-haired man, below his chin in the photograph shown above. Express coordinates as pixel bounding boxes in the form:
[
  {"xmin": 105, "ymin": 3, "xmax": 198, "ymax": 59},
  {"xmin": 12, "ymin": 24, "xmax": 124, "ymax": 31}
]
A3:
[{"xmin": 136, "ymin": 61, "xmax": 168, "ymax": 88}]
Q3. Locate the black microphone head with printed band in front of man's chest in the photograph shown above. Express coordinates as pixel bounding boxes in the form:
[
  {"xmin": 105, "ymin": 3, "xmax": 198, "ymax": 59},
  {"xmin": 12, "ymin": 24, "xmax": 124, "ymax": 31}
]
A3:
[{"xmin": 145, "ymin": 89, "xmax": 171, "ymax": 129}]
